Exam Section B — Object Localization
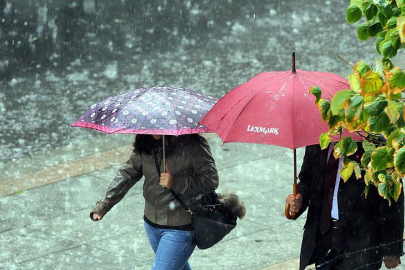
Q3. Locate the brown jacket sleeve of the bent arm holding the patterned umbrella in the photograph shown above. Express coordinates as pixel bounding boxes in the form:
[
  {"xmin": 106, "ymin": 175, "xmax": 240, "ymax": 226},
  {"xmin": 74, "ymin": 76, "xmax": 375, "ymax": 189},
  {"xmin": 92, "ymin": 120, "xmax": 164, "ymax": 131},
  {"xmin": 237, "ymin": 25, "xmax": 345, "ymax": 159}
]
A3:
[{"xmin": 171, "ymin": 138, "xmax": 219, "ymax": 195}]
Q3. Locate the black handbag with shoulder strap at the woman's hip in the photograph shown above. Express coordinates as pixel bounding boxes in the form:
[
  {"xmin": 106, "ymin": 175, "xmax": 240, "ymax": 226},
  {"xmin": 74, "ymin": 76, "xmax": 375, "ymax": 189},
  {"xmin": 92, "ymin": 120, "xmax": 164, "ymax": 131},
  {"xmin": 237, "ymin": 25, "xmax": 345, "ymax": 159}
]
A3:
[{"xmin": 154, "ymin": 151, "xmax": 237, "ymax": 249}]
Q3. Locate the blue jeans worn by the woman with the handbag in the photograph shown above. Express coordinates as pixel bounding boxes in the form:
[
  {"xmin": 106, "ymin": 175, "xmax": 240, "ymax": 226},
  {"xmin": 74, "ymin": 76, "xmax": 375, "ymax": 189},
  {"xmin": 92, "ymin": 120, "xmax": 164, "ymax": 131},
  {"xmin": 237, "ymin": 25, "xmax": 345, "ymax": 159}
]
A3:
[{"xmin": 144, "ymin": 222, "xmax": 195, "ymax": 270}]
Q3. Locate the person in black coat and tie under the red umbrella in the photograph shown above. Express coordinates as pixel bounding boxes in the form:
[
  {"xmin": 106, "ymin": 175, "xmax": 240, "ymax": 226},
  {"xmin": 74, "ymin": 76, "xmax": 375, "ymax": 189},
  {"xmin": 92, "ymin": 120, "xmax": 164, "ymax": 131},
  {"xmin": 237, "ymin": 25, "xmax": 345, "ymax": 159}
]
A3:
[{"xmin": 286, "ymin": 143, "xmax": 404, "ymax": 270}]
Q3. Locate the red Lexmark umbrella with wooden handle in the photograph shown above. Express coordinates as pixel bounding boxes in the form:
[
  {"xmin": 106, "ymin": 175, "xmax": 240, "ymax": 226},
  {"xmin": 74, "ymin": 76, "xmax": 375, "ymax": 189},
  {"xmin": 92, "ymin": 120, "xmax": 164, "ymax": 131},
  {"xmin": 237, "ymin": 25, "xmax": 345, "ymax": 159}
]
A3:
[{"xmin": 200, "ymin": 52, "xmax": 360, "ymax": 218}]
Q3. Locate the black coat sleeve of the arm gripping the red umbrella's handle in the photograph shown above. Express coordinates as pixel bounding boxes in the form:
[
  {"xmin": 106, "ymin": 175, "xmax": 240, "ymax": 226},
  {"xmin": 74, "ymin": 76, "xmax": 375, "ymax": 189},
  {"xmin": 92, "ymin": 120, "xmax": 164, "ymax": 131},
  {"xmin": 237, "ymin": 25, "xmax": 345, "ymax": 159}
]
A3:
[{"xmin": 294, "ymin": 147, "xmax": 313, "ymax": 219}]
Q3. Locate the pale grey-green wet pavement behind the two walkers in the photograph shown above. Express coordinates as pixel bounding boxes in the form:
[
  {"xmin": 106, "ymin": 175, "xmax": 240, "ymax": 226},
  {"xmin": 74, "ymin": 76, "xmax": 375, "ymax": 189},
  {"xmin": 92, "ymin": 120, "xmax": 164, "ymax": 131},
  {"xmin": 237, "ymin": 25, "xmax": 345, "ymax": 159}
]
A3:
[{"xmin": 0, "ymin": 134, "xmax": 405, "ymax": 270}]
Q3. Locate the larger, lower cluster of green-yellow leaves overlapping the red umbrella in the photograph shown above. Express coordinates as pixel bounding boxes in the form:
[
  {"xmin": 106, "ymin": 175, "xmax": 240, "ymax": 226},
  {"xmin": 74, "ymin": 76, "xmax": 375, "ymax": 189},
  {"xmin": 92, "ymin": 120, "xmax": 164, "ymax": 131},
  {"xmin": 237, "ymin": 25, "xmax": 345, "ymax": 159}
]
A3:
[{"xmin": 310, "ymin": 60, "xmax": 405, "ymax": 201}]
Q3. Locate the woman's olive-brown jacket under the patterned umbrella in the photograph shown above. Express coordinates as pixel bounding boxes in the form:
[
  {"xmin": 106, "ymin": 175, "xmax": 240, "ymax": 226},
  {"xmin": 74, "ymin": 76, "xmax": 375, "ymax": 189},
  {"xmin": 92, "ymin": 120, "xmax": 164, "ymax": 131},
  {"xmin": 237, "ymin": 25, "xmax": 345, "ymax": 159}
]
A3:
[{"xmin": 91, "ymin": 135, "xmax": 218, "ymax": 226}]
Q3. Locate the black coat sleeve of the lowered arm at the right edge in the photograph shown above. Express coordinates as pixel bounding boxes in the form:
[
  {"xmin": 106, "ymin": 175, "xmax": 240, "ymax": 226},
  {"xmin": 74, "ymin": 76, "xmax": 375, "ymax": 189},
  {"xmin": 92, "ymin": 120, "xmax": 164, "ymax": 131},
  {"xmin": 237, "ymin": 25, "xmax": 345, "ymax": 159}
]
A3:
[{"xmin": 380, "ymin": 181, "xmax": 404, "ymax": 256}]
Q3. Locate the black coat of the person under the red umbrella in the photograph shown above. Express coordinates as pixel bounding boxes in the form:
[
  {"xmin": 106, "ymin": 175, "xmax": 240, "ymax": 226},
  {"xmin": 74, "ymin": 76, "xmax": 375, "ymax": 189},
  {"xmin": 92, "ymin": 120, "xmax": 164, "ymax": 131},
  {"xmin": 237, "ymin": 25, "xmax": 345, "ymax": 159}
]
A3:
[{"xmin": 296, "ymin": 145, "xmax": 404, "ymax": 269}]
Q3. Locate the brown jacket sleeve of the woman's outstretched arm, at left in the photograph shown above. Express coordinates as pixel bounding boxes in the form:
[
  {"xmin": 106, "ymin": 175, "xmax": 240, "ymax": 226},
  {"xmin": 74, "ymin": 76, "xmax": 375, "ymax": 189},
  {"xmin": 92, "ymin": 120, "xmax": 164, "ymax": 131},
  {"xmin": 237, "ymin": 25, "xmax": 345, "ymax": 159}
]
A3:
[{"xmin": 90, "ymin": 151, "xmax": 143, "ymax": 220}]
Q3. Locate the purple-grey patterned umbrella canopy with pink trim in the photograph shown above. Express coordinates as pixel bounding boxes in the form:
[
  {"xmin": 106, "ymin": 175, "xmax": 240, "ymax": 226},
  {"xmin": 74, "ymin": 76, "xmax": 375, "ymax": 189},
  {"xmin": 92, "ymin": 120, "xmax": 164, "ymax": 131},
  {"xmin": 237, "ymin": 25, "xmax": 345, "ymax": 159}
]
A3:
[{"xmin": 72, "ymin": 87, "xmax": 218, "ymax": 135}]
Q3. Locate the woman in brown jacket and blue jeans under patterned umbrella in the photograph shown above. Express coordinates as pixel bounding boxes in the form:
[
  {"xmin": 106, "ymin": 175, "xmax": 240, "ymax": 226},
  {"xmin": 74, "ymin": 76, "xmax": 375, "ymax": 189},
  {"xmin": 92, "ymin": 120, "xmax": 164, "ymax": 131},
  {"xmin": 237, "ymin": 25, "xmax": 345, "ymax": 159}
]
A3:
[{"xmin": 90, "ymin": 135, "xmax": 218, "ymax": 270}]
